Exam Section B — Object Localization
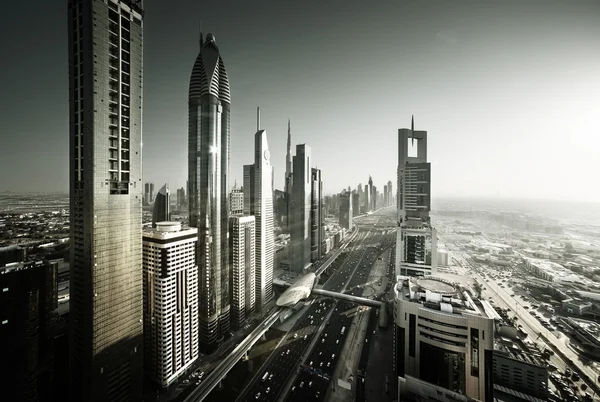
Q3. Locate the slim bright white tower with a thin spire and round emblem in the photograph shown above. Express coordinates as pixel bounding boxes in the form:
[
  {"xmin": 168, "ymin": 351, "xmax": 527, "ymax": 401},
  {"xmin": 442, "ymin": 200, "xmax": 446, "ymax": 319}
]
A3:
[{"xmin": 244, "ymin": 110, "xmax": 275, "ymax": 311}]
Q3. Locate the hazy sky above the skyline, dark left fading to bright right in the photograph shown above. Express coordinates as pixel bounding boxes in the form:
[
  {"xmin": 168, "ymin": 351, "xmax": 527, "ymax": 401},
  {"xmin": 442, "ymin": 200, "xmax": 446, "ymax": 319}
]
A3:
[{"xmin": 0, "ymin": 0, "xmax": 600, "ymax": 201}]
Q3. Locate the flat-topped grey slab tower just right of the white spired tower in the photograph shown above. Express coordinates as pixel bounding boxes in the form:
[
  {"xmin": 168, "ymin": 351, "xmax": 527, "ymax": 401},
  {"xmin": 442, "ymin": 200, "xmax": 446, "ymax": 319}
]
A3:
[{"xmin": 290, "ymin": 144, "xmax": 311, "ymax": 272}]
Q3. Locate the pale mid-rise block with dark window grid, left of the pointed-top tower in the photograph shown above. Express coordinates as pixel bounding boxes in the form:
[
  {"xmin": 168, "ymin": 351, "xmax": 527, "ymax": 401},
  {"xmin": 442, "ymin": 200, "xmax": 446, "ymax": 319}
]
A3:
[{"xmin": 142, "ymin": 221, "xmax": 199, "ymax": 387}]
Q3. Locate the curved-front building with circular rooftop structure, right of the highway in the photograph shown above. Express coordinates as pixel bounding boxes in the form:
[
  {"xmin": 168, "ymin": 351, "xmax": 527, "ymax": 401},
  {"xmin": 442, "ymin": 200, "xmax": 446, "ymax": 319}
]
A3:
[{"xmin": 394, "ymin": 276, "xmax": 497, "ymax": 400}]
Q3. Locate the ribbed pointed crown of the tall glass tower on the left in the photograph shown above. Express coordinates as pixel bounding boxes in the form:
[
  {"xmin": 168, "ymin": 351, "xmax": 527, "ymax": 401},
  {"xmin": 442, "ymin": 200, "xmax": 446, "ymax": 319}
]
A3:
[{"xmin": 189, "ymin": 34, "xmax": 231, "ymax": 104}]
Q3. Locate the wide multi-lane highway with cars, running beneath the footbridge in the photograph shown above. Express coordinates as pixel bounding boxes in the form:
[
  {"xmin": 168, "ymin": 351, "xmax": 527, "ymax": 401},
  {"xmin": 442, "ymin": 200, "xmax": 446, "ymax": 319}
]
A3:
[{"xmin": 237, "ymin": 209, "xmax": 394, "ymax": 402}]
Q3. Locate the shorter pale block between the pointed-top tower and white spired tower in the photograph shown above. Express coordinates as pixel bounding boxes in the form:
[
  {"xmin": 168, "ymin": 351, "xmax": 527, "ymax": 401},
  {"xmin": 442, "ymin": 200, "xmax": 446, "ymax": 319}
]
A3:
[{"xmin": 229, "ymin": 215, "xmax": 256, "ymax": 329}]
